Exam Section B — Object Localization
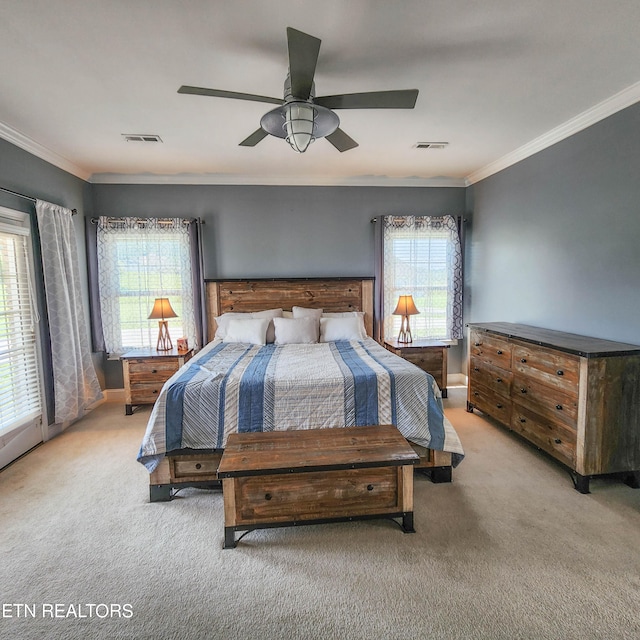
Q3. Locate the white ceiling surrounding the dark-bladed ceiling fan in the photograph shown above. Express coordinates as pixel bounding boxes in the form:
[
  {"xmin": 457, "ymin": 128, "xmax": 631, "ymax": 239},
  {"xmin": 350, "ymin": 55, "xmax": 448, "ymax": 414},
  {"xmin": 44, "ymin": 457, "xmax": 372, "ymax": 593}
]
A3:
[{"xmin": 0, "ymin": 0, "xmax": 640, "ymax": 185}]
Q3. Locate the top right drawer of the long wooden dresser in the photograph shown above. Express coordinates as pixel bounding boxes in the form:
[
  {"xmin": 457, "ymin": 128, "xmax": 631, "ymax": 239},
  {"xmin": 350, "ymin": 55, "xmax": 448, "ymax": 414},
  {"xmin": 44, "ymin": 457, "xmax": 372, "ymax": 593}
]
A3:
[{"xmin": 513, "ymin": 344, "xmax": 580, "ymax": 397}]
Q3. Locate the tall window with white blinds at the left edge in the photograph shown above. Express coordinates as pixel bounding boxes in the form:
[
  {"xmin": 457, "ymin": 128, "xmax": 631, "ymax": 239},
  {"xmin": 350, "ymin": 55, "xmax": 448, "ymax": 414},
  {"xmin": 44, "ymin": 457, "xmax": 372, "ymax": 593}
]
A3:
[{"xmin": 0, "ymin": 207, "xmax": 42, "ymax": 442}]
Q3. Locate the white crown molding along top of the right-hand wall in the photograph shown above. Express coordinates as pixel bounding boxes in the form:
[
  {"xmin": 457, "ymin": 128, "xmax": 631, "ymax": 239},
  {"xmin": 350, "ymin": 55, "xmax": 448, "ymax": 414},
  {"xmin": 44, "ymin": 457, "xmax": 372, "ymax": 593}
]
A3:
[{"xmin": 465, "ymin": 82, "xmax": 640, "ymax": 186}]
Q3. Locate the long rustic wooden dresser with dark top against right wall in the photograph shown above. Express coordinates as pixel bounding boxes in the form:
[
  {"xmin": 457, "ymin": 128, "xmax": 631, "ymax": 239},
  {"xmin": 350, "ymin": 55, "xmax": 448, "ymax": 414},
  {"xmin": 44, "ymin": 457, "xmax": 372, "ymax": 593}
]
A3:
[{"xmin": 467, "ymin": 322, "xmax": 640, "ymax": 493}]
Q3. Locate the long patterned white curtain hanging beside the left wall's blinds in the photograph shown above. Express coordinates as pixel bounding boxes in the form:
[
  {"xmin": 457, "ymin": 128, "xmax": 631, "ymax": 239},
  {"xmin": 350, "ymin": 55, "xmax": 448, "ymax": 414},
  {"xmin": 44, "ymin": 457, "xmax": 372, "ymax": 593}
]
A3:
[{"xmin": 36, "ymin": 200, "xmax": 102, "ymax": 424}]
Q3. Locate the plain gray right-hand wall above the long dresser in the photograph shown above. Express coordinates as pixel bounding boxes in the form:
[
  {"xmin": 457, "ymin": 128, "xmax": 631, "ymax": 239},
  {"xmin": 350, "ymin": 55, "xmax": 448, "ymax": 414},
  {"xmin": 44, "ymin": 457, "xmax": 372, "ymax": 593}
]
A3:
[{"xmin": 466, "ymin": 104, "xmax": 640, "ymax": 368}]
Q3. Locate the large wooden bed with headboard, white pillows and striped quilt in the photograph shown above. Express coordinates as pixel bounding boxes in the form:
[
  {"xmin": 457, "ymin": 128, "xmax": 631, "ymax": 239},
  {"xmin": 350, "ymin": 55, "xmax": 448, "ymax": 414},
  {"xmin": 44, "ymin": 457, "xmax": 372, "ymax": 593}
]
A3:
[{"xmin": 138, "ymin": 278, "xmax": 464, "ymax": 502}]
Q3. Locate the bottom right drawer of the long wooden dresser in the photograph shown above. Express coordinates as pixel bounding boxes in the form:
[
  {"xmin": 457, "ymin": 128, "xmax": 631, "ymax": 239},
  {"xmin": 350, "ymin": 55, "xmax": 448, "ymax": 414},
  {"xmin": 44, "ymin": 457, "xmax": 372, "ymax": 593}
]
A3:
[{"xmin": 511, "ymin": 402, "xmax": 576, "ymax": 467}]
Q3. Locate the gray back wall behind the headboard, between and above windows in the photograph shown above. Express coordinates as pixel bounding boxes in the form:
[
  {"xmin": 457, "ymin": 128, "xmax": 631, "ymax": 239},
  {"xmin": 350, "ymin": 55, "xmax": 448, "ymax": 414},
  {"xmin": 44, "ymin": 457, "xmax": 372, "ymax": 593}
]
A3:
[{"xmin": 91, "ymin": 184, "xmax": 465, "ymax": 388}]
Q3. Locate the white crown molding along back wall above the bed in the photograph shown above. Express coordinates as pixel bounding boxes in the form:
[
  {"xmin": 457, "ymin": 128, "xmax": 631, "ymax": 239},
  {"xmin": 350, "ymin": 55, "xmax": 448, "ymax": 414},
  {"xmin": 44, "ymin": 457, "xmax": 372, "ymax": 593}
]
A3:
[{"xmin": 89, "ymin": 173, "xmax": 466, "ymax": 187}]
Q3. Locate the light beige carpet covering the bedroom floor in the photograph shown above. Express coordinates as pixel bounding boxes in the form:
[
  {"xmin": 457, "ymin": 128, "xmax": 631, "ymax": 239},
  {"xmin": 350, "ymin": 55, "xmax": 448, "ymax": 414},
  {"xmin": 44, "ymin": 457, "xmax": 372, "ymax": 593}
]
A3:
[{"xmin": 0, "ymin": 388, "xmax": 640, "ymax": 640}]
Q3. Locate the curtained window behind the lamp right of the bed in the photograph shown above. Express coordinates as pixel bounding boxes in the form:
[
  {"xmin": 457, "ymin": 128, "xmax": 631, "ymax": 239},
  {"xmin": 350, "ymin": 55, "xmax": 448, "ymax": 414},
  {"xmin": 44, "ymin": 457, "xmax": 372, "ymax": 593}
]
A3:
[{"xmin": 382, "ymin": 216, "xmax": 462, "ymax": 340}]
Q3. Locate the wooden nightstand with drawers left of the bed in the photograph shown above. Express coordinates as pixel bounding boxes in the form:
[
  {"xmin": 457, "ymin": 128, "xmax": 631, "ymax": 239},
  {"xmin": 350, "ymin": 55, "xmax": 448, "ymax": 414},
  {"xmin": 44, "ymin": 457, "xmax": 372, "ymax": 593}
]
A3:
[{"xmin": 121, "ymin": 348, "xmax": 193, "ymax": 416}]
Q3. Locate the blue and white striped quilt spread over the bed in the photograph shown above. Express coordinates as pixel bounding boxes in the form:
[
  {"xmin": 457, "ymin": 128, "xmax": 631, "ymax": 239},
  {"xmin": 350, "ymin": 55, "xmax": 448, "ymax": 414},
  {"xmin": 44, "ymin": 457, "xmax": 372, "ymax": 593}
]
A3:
[{"xmin": 138, "ymin": 338, "xmax": 464, "ymax": 471}]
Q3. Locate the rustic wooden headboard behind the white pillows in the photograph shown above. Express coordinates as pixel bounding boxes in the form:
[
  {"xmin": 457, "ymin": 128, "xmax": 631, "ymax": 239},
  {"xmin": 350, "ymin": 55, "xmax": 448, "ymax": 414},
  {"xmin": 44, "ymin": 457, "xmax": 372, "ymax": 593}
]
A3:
[{"xmin": 206, "ymin": 278, "xmax": 374, "ymax": 341}]
